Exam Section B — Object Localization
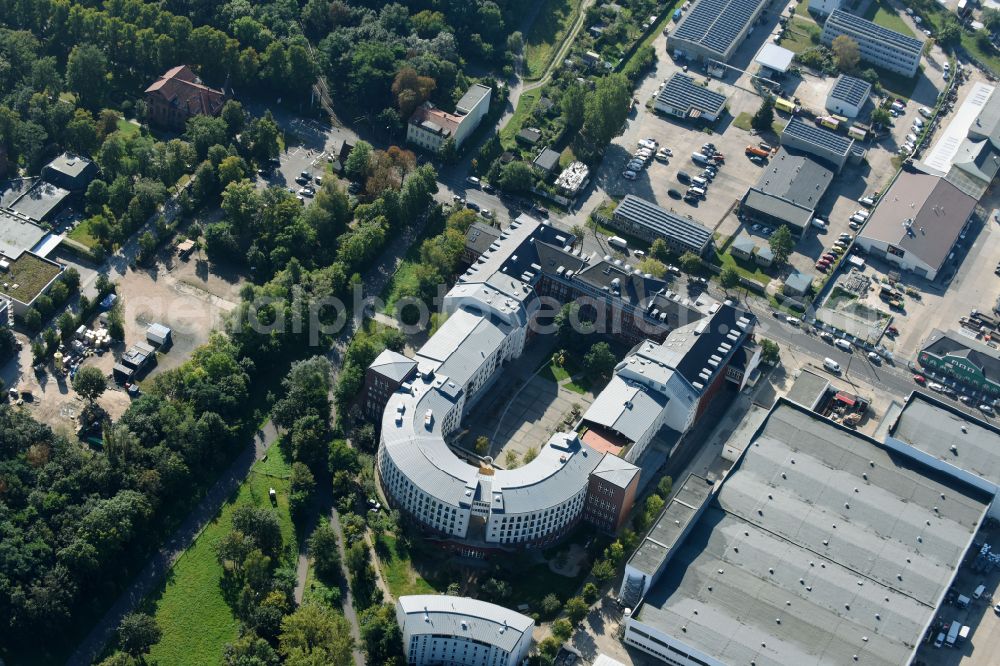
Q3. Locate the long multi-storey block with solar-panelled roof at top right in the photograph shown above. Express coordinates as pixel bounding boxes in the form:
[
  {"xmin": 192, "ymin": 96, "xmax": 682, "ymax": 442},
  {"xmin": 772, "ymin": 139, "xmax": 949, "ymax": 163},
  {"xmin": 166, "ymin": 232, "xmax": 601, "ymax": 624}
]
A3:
[{"xmin": 822, "ymin": 9, "xmax": 924, "ymax": 76}]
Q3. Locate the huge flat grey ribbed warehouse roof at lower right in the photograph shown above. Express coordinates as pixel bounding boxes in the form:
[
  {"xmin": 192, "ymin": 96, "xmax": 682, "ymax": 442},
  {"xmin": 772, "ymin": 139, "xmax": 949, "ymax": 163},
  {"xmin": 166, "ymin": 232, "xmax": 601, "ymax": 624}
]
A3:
[{"xmin": 633, "ymin": 399, "xmax": 989, "ymax": 666}]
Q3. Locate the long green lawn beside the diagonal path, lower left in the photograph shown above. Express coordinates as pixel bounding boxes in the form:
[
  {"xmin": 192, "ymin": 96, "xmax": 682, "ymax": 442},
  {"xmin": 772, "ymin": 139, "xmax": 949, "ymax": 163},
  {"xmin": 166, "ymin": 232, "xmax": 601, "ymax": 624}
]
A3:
[{"xmin": 146, "ymin": 445, "xmax": 297, "ymax": 666}]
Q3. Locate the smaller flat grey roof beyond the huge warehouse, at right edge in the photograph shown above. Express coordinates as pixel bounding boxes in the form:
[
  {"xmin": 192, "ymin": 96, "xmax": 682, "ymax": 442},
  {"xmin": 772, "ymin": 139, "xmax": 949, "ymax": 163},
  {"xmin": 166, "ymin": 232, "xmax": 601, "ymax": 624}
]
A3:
[{"xmin": 889, "ymin": 391, "xmax": 1000, "ymax": 485}]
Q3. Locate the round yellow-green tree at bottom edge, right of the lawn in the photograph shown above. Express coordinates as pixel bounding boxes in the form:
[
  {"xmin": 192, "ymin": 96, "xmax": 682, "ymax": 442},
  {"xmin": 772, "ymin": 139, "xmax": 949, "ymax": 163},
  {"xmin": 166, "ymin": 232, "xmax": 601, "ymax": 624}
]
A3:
[{"xmin": 278, "ymin": 603, "xmax": 354, "ymax": 666}]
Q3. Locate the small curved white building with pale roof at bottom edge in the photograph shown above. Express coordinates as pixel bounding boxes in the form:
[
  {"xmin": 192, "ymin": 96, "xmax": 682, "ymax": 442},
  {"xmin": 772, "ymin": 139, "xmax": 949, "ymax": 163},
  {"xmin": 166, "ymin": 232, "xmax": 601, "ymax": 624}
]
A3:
[{"xmin": 396, "ymin": 594, "xmax": 535, "ymax": 666}]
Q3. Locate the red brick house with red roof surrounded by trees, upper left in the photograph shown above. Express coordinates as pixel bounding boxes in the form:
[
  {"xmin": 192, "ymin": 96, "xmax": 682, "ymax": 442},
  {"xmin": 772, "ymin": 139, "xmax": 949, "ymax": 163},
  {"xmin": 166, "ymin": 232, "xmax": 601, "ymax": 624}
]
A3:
[{"xmin": 146, "ymin": 65, "xmax": 226, "ymax": 130}]
